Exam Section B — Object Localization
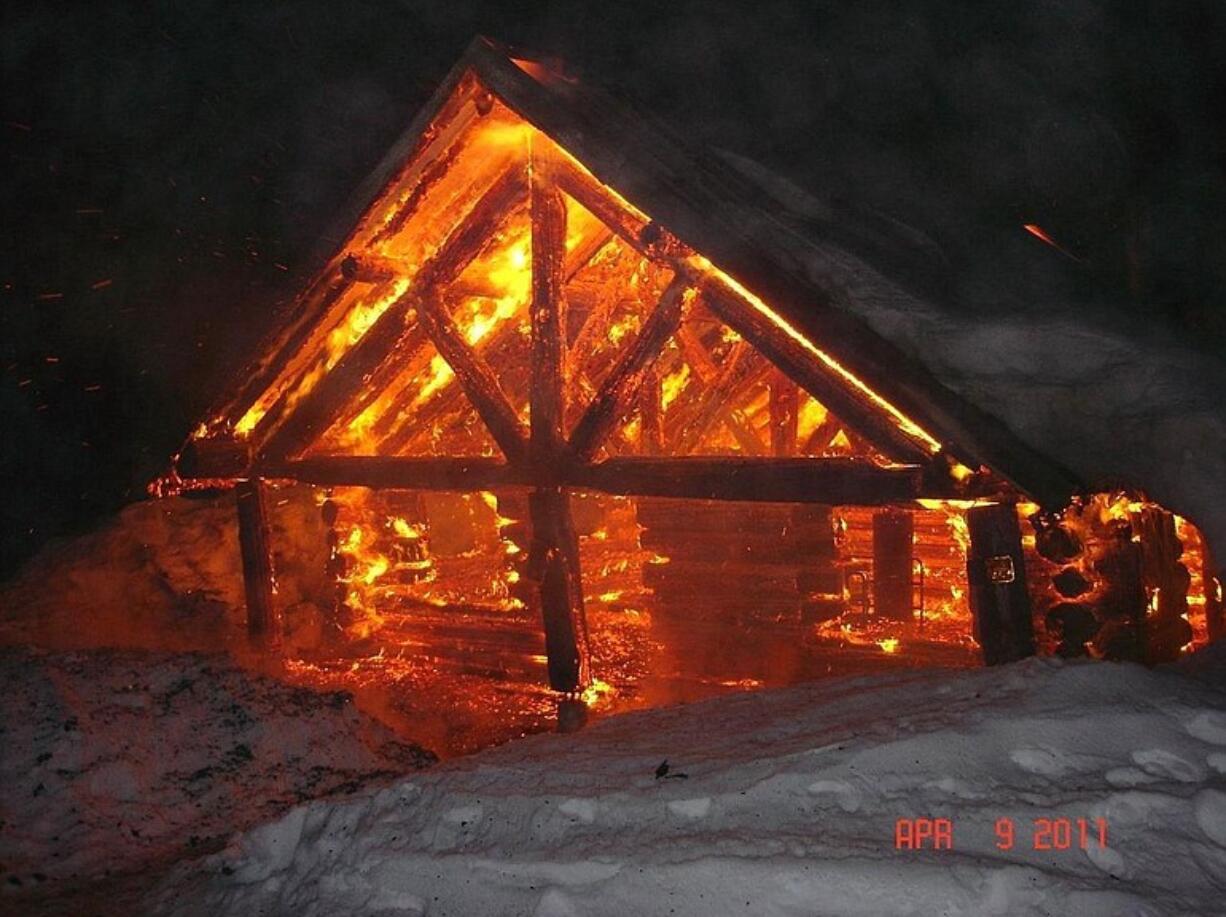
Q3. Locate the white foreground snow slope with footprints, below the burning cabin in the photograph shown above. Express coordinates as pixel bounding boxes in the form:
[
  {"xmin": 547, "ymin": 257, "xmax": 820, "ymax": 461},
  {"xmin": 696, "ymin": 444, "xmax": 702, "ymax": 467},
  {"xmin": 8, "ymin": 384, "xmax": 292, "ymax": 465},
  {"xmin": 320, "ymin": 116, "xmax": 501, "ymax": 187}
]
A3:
[{"xmin": 150, "ymin": 653, "xmax": 1226, "ymax": 917}]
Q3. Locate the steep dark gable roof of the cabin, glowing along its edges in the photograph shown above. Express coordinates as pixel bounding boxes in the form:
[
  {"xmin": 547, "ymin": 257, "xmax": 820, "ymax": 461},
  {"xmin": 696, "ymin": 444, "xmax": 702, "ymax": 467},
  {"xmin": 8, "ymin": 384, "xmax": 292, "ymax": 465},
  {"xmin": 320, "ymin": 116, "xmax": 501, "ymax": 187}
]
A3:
[{"xmin": 178, "ymin": 38, "xmax": 1078, "ymax": 506}]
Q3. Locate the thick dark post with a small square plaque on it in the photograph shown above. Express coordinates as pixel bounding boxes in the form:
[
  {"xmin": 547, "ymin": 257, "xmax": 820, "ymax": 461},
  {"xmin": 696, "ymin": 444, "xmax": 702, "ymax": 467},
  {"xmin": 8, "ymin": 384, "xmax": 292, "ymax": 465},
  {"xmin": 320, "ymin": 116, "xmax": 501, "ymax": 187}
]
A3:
[{"xmin": 966, "ymin": 503, "xmax": 1035, "ymax": 666}]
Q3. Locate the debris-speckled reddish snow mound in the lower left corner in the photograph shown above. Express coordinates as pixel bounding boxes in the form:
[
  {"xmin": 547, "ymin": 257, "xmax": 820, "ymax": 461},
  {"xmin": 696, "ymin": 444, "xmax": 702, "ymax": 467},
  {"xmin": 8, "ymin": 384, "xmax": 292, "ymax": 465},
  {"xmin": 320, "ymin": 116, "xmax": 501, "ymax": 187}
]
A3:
[{"xmin": 0, "ymin": 649, "xmax": 434, "ymax": 910}]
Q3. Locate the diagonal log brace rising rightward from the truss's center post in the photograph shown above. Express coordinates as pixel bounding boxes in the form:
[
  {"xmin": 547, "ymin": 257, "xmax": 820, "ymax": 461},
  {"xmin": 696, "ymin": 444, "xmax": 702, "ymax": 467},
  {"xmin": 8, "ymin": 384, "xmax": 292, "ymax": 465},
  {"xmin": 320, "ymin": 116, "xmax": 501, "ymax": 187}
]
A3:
[{"xmin": 570, "ymin": 277, "xmax": 687, "ymax": 460}]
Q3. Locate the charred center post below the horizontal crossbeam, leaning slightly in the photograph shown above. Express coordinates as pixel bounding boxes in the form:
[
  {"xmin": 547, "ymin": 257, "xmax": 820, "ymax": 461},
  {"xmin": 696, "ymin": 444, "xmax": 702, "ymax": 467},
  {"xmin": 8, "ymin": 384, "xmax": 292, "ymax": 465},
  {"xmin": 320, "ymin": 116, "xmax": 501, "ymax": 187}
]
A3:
[{"xmin": 527, "ymin": 488, "xmax": 587, "ymax": 693}]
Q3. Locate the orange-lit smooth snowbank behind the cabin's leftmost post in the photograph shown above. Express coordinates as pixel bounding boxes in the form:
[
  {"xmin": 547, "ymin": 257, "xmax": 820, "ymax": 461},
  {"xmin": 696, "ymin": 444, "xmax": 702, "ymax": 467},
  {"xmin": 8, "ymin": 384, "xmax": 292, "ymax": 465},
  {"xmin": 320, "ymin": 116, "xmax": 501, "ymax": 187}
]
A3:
[{"xmin": 0, "ymin": 488, "xmax": 326, "ymax": 658}]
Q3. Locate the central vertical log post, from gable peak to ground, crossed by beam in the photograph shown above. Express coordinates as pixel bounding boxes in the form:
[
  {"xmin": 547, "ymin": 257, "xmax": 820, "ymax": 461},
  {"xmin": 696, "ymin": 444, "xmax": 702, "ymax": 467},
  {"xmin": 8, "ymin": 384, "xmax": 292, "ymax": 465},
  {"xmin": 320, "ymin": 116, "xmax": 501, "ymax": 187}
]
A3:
[{"xmin": 527, "ymin": 151, "xmax": 587, "ymax": 694}]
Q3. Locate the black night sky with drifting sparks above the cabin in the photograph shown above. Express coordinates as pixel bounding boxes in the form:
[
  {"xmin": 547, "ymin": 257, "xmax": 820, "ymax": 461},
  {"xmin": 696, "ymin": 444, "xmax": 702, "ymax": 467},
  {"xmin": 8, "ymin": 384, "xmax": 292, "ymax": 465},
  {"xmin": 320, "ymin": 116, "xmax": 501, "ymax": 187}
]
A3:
[{"xmin": 0, "ymin": 0, "xmax": 1226, "ymax": 573}]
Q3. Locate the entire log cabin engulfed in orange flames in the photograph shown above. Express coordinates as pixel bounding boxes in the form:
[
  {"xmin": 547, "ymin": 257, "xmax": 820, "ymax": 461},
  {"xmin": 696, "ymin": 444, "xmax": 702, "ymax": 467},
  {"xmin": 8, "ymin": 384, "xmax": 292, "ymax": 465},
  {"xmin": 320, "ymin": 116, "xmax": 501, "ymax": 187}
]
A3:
[{"xmin": 159, "ymin": 39, "xmax": 1221, "ymax": 730}]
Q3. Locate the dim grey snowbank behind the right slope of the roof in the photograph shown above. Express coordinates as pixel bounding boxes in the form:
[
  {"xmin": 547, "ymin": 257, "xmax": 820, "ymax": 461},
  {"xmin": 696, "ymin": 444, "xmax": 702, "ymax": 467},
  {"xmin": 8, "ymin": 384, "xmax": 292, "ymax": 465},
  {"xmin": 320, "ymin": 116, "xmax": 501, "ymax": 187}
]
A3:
[{"xmin": 725, "ymin": 153, "xmax": 1226, "ymax": 559}]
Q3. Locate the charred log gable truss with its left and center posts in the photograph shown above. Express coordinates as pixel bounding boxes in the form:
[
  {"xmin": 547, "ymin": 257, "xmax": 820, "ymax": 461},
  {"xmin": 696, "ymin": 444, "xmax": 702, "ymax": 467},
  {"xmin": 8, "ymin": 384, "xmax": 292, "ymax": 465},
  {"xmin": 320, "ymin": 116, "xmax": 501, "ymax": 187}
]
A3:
[{"xmin": 179, "ymin": 79, "xmax": 1034, "ymax": 691}]
